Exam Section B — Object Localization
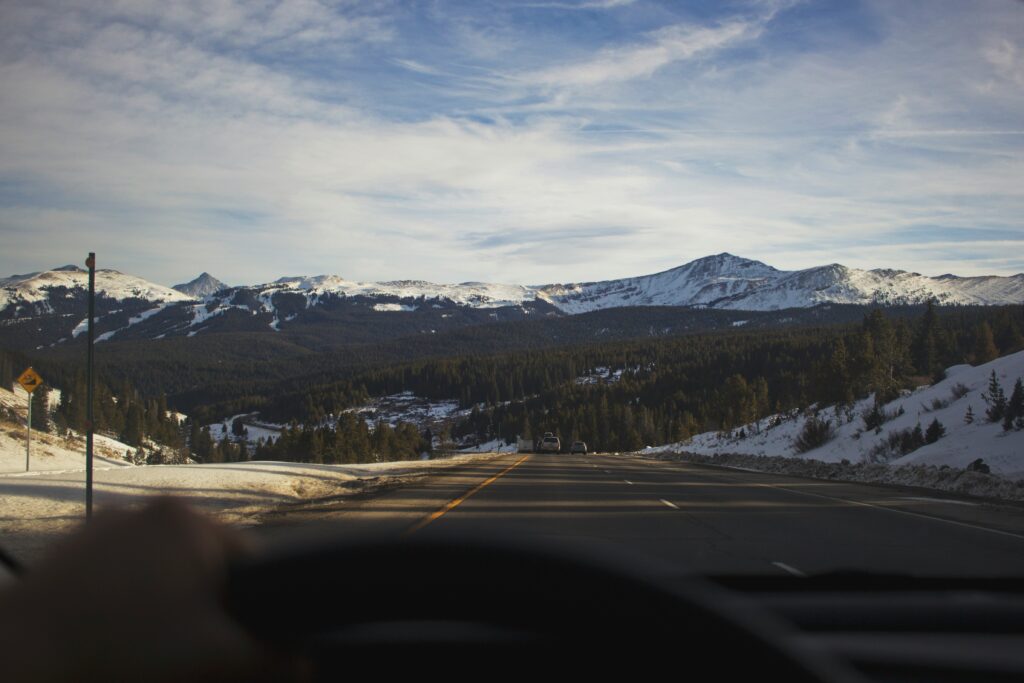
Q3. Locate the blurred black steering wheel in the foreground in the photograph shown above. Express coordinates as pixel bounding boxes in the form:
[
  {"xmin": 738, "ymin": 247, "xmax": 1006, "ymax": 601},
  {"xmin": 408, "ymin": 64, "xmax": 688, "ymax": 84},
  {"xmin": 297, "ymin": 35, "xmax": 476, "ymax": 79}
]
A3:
[{"xmin": 227, "ymin": 539, "xmax": 859, "ymax": 683}]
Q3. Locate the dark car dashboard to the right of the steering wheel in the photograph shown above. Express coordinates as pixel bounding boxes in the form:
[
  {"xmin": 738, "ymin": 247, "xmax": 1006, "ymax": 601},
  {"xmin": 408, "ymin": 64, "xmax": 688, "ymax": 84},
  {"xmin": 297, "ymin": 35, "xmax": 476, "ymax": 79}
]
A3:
[{"xmin": 712, "ymin": 572, "xmax": 1024, "ymax": 683}]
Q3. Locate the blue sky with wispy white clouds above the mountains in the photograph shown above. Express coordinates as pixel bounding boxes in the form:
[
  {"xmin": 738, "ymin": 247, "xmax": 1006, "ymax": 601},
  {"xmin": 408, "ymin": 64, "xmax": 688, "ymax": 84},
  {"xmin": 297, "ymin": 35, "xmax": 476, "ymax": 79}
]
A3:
[{"xmin": 0, "ymin": 0, "xmax": 1024, "ymax": 285}]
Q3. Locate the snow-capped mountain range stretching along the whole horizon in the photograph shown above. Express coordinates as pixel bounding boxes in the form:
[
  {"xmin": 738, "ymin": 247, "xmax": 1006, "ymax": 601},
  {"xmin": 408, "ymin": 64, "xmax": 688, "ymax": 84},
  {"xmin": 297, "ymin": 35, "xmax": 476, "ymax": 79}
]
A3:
[{"xmin": 0, "ymin": 254, "xmax": 1024, "ymax": 345}]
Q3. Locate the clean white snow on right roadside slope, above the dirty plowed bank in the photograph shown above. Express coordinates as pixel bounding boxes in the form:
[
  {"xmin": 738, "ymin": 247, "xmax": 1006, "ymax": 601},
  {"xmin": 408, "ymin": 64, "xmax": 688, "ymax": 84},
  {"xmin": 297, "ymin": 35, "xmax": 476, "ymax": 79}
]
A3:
[{"xmin": 643, "ymin": 351, "xmax": 1024, "ymax": 479}]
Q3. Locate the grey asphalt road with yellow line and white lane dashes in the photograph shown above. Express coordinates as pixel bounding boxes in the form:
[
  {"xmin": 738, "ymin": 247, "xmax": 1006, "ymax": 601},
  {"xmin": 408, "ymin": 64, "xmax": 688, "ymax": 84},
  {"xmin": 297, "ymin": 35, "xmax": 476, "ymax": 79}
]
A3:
[{"xmin": 267, "ymin": 454, "xmax": 1024, "ymax": 577}]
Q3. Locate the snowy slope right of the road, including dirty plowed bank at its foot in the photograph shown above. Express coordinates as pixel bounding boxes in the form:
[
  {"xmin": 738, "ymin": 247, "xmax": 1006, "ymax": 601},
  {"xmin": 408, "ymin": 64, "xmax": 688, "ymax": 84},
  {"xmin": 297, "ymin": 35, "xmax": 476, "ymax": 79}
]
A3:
[{"xmin": 640, "ymin": 351, "xmax": 1024, "ymax": 498}]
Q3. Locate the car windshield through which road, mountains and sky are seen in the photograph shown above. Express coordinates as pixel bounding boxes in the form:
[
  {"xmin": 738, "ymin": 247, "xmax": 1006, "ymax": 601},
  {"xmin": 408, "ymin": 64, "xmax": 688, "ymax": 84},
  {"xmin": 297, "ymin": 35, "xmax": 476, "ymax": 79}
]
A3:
[{"xmin": 0, "ymin": 0, "xmax": 1024, "ymax": 589}]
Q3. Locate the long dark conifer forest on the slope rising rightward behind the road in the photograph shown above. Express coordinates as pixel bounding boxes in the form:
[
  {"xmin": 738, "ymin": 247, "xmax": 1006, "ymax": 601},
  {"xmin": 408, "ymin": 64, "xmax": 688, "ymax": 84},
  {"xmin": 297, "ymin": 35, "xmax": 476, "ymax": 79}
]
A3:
[{"xmin": 249, "ymin": 305, "xmax": 1024, "ymax": 451}]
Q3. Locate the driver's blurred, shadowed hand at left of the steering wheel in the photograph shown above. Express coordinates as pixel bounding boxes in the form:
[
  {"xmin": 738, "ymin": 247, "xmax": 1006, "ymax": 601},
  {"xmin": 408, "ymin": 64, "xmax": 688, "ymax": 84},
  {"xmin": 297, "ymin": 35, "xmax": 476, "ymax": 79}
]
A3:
[{"xmin": 0, "ymin": 499, "xmax": 299, "ymax": 681}]
